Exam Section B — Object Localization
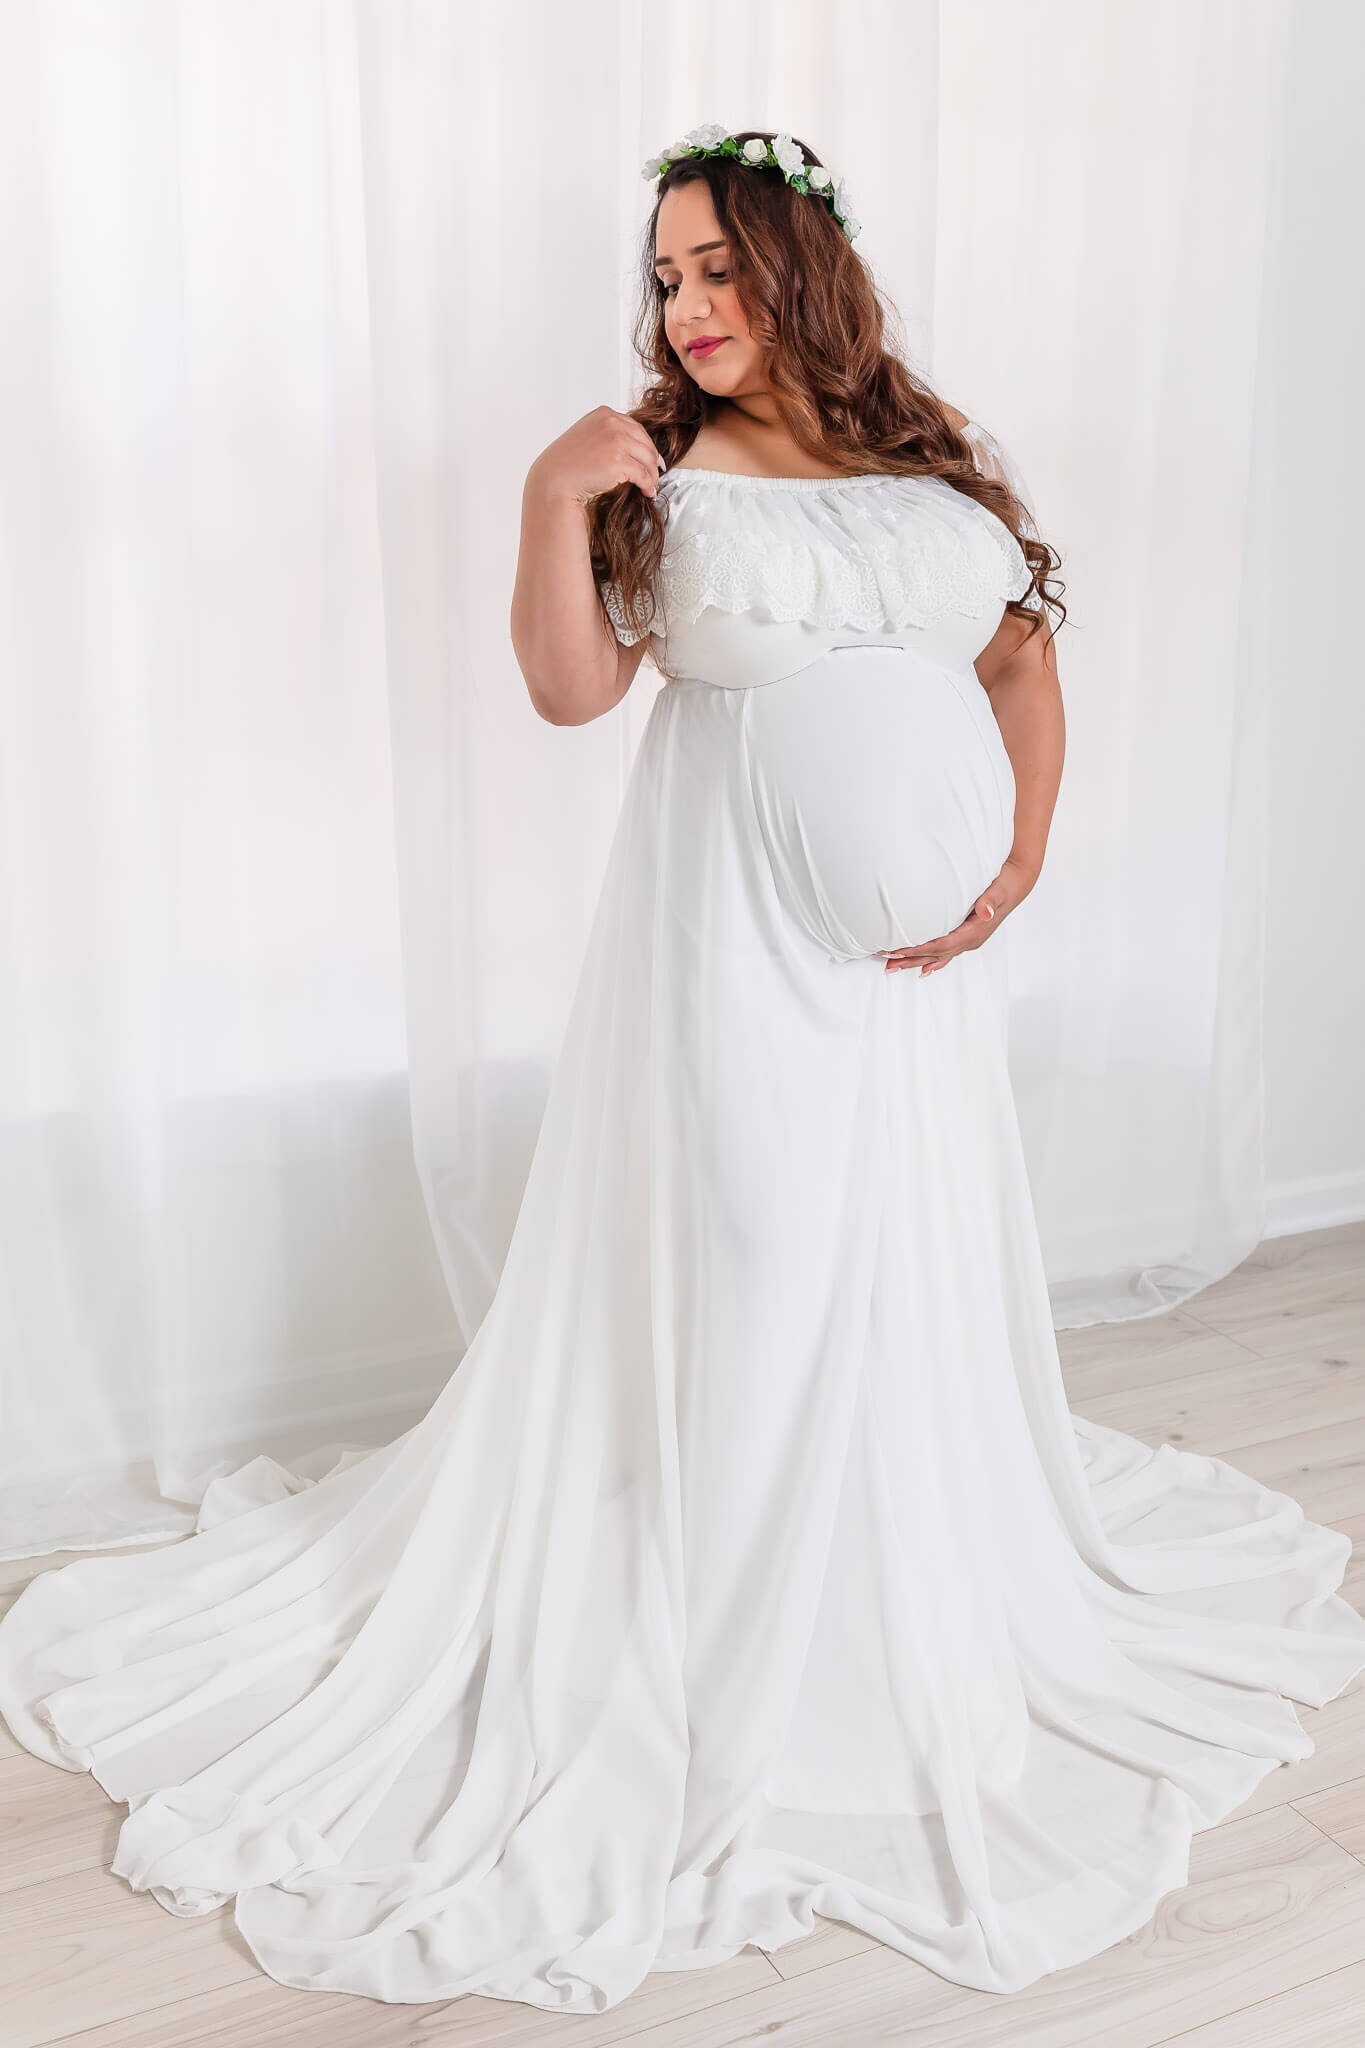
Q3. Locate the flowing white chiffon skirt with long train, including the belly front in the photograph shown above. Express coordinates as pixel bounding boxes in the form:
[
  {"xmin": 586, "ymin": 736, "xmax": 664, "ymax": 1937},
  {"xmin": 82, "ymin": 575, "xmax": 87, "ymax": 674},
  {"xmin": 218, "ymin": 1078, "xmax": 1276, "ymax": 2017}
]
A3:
[{"xmin": 0, "ymin": 647, "xmax": 1365, "ymax": 2011}]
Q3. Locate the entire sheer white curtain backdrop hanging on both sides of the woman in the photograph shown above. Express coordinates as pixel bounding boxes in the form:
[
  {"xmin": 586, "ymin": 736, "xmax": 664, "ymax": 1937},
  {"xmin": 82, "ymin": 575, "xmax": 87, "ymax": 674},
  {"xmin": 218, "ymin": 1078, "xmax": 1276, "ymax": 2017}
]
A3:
[{"xmin": 0, "ymin": 0, "xmax": 1273, "ymax": 1554}]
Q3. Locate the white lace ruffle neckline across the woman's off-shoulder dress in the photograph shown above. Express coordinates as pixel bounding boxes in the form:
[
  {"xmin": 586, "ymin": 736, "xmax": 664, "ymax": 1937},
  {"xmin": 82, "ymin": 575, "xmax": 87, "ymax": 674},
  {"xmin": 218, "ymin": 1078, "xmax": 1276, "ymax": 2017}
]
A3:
[{"xmin": 604, "ymin": 469, "xmax": 1031, "ymax": 645}]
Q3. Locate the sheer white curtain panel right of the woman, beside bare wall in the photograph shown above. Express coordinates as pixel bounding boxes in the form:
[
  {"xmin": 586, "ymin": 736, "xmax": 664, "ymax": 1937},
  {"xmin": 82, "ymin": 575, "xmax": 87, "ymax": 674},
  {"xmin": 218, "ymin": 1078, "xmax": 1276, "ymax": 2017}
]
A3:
[{"xmin": 931, "ymin": 0, "xmax": 1285, "ymax": 1325}]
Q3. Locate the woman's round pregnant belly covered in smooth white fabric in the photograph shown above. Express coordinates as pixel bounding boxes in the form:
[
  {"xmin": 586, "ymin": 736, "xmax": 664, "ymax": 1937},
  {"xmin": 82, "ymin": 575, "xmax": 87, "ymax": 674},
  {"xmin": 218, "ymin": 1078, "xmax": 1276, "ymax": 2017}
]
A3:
[{"xmin": 745, "ymin": 647, "xmax": 1015, "ymax": 958}]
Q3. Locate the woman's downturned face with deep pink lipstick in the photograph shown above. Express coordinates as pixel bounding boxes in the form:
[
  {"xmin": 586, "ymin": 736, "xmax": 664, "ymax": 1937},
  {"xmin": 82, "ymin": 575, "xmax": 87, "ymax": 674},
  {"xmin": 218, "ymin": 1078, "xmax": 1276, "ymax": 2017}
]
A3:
[{"xmin": 655, "ymin": 178, "xmax": 767, "ymax": 397}]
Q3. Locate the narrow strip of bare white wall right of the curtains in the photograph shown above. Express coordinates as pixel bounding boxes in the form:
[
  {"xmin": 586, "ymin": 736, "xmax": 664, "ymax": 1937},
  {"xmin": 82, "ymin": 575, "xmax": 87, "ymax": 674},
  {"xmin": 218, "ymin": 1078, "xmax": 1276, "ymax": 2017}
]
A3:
[{"xmin": 1265, "ymin": 0, "xmax": 1365, "ymax": 1231}]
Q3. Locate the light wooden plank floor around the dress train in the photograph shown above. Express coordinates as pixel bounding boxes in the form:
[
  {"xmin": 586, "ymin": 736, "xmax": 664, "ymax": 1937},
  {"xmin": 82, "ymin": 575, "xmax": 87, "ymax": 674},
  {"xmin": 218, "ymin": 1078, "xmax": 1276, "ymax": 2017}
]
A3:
[{"xmin": 0, "ymin": 1225, "xmax": 1365, "ymax": 2048}]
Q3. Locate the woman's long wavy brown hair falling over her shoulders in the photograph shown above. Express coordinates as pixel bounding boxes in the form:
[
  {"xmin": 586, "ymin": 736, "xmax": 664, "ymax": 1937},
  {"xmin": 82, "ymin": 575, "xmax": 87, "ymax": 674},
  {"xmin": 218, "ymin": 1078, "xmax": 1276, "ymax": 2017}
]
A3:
[{"xmin": 589, "ymin": 129, "xmax": 1066, "ymax": 663}]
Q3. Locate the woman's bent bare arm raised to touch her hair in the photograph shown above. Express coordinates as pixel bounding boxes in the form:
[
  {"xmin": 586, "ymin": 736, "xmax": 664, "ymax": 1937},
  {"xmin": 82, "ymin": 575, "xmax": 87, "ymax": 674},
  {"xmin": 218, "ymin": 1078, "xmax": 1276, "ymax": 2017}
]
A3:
[{"xmin": 510, "ymin": 406, "xmax": 659, "ymax": 725}]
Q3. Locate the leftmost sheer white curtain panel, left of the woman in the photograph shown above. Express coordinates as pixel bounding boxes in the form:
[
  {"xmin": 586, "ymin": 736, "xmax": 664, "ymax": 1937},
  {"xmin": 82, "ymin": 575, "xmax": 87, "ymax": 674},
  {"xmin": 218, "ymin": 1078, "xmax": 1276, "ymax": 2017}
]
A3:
[{"xmin": 0, "ymin": 0, "xmax": 458, "ymax": 1552}]
